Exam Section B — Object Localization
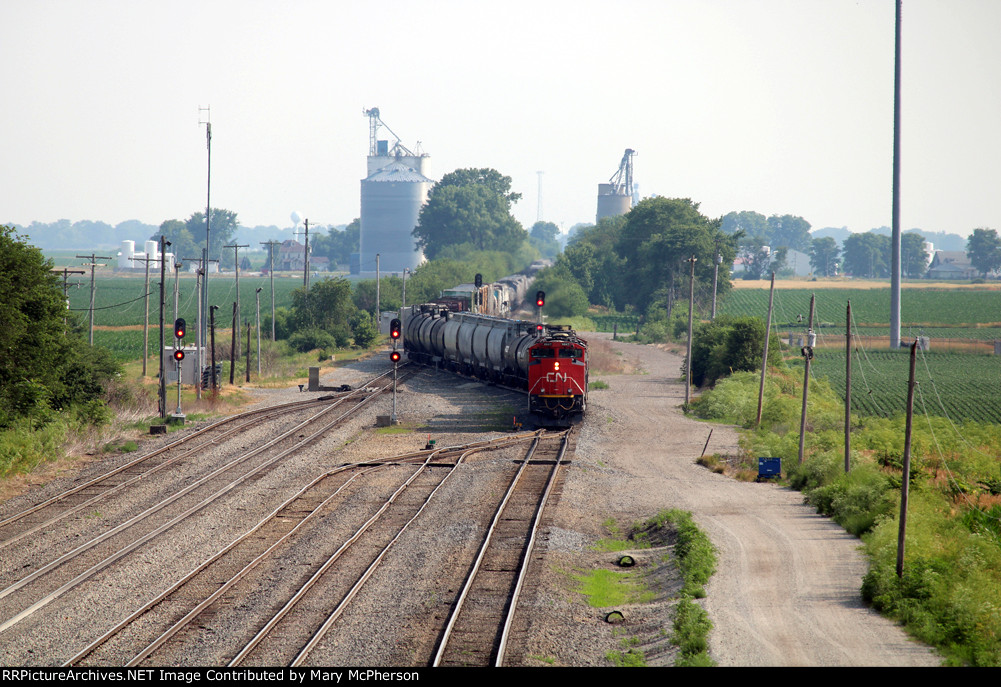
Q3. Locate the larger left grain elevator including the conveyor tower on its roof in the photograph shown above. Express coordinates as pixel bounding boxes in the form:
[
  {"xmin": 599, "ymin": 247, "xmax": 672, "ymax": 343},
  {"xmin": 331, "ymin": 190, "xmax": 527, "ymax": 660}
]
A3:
[{"xmin": 358, "ymin": 108, "xmax": 433, "ymax": 274}]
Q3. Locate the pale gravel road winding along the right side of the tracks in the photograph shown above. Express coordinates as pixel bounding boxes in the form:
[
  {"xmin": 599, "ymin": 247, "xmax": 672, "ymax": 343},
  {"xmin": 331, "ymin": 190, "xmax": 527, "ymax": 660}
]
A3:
[{"xmin": 562, "ymin": 334, "xmax": 939, "ymax": 666}]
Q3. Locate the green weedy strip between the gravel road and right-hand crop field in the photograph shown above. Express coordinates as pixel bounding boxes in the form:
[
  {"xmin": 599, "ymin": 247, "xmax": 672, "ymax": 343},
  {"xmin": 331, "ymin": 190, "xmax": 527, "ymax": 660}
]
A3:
[{"xmin": 698, "ymin": 372, "xmax": 1001, "ymax": 667}]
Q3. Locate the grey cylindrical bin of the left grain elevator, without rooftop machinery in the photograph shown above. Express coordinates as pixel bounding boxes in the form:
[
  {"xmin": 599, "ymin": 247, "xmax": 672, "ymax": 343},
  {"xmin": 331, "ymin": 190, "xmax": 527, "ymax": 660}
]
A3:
[{"xmin": 358, "ymin": 159, "xmax": 433, "ymax": 274}]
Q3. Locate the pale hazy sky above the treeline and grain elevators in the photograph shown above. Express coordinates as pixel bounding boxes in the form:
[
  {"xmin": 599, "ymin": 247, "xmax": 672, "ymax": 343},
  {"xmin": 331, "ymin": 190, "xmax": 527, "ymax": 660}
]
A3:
[{"xmin": 0, "ymin": 0, "xmax": 1001, "ymax": 239}]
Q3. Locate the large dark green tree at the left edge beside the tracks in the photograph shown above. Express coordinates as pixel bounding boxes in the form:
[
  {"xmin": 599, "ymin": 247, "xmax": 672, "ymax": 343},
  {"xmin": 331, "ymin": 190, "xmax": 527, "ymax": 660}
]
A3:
[{"xmin": 0, "ymin": 226, "xmax": 118, "ymax": 428}]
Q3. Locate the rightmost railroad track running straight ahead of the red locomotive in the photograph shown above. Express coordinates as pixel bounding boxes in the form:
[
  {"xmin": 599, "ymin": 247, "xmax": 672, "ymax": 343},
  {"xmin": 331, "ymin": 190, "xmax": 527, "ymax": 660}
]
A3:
[{"xmin": 431, "ymin": 431, "xmax": 572, "ymax": 666}]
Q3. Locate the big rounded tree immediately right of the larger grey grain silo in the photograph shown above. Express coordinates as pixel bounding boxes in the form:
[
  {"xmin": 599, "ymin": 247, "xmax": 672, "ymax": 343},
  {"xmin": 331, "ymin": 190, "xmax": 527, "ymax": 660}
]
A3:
[{"xmin": 413, "ymin": 169, "xmax": 528, "ymax": 259}]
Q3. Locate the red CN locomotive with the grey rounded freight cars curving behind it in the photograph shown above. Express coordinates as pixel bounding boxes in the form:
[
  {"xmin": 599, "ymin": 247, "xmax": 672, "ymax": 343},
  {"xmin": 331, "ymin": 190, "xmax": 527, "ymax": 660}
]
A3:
[{"xmin": 403, "ymin": 292, "xmax": 588, "ymax": 426}]
